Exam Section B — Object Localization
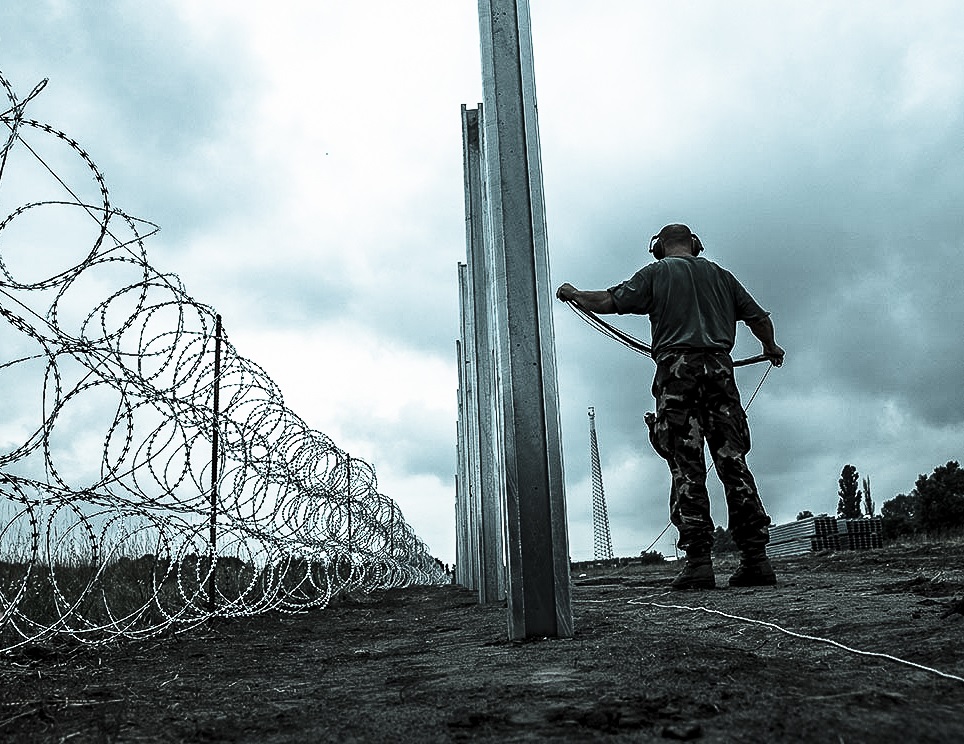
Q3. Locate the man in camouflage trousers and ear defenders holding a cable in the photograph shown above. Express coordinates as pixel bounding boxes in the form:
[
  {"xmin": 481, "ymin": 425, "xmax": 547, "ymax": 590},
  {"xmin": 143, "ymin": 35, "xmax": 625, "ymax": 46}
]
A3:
[{"xmin": 556, "ymin": 224, "xmax": 784, "ymax": 589}]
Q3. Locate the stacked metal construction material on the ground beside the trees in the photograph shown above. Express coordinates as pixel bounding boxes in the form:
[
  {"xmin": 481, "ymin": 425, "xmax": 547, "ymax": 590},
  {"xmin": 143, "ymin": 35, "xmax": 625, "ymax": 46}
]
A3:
[{"xmin": 767, "ymin": 514, "xmax": 883, "ymax": 558}]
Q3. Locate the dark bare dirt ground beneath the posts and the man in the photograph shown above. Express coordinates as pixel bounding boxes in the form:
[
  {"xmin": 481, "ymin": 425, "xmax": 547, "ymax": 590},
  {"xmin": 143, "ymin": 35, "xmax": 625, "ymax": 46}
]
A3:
[{"xmin": 0, "ymin": 544, "xmax": 964, "ymax": 744}]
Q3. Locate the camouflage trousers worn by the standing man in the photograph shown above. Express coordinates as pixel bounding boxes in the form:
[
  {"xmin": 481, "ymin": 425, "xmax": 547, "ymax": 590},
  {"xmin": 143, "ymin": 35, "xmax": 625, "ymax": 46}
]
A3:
[{"xmin": 646, "ymin": 351, "xmax": 770, "ymax": 554}]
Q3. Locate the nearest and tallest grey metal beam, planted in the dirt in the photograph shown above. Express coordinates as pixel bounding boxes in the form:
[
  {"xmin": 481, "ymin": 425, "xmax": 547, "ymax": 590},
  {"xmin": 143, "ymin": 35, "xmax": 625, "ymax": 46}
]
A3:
[{"xmin": 479, "ymin": 0, "xmax": 572, "ymax": 638}]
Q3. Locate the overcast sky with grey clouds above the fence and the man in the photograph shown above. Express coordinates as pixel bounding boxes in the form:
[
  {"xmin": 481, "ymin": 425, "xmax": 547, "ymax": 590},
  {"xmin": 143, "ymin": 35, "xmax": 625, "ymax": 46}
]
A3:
[{"xmin": 0, "ymin": 0, "xmax": 964, "ymax": 562}]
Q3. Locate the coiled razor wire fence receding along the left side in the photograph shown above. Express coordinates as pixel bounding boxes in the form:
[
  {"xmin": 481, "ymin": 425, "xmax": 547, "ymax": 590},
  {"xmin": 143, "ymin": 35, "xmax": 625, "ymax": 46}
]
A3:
[{"xmin": 0, "ymin": 73, "xmax": 447, "ymax": 650}]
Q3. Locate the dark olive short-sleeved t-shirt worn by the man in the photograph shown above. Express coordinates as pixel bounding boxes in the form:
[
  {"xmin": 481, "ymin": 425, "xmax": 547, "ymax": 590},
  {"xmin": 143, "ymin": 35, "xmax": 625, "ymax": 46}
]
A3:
[{"xmin": 609, "ymin": 256, "xmax": 769, "ymax": 357}]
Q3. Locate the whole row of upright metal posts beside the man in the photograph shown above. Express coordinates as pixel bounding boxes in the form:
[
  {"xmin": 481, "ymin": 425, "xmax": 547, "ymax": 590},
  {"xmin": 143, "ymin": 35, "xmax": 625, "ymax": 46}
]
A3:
[{"xmin": 456, "ymin": 0, "xmax": 572, "ymax": 638}]
